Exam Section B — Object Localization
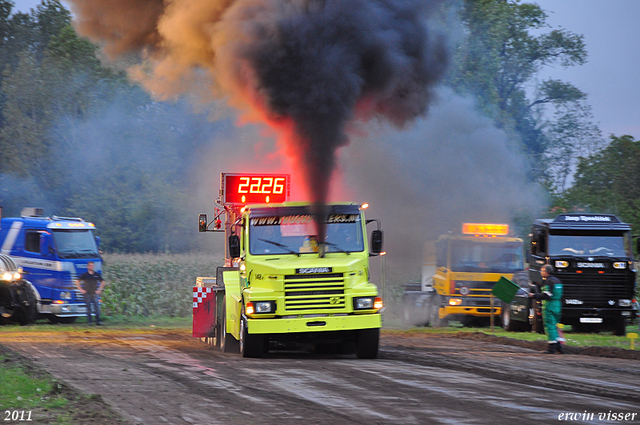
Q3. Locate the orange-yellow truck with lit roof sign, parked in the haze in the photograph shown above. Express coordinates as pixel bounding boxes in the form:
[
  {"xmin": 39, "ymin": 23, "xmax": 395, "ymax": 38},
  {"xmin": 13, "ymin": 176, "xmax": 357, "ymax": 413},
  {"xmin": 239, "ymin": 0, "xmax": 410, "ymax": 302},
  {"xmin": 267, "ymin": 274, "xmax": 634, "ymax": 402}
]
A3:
[{"xmin": 402, "ymin": 223, "xmax": 524, "ymax": 326}]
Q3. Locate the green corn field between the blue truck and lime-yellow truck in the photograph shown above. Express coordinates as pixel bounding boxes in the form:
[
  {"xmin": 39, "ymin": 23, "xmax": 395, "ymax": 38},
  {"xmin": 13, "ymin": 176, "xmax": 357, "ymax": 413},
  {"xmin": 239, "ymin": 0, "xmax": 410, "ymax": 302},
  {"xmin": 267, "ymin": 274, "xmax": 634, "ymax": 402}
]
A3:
[{"xmin": 102, "ymin": 253, "xmax": 222, "ymax": 317}]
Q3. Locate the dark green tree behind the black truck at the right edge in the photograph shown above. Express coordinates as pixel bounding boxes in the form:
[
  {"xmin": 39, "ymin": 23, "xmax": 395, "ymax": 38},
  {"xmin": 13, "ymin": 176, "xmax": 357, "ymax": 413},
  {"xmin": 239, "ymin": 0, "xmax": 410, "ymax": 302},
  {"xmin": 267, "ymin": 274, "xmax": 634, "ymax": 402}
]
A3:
[{"xmin": 561, "ymin": 135, "xmax": 640, "ymax": 228}]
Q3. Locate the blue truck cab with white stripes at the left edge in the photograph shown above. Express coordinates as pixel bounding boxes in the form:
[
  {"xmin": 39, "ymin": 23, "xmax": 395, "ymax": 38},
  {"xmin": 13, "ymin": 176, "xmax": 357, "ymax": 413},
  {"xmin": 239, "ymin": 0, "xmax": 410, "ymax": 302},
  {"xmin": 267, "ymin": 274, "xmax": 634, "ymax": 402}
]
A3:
[{"xmin": 0, "ymin": 208, "xmax": 102, "ymax": 323}]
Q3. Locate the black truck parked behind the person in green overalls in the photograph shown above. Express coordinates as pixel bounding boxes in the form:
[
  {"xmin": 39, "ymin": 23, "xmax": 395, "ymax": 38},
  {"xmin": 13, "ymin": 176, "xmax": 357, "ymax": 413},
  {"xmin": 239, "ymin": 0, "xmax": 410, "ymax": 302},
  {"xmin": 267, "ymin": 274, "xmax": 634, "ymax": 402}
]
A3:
[{"xmin": 524, "ymin": 214, "xmax": 636, "ymax": 335}]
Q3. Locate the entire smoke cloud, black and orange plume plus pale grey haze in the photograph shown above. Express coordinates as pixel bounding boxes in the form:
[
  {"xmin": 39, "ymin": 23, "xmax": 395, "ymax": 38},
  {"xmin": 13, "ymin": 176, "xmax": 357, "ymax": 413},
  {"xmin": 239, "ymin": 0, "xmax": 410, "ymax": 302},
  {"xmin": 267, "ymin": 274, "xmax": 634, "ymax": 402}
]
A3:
[{"xmin": 58, "ymin": 0, "xmax": 544, "ymax": 283}]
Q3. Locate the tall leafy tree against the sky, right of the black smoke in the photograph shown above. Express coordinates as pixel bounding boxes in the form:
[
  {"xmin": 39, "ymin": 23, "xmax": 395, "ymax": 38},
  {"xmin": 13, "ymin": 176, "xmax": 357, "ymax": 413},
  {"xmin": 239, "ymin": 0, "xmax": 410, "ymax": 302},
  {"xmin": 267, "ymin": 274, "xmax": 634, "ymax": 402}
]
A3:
[{"xmin": 450, "ymin": 0, "xmax": 589, "ymax": 180}]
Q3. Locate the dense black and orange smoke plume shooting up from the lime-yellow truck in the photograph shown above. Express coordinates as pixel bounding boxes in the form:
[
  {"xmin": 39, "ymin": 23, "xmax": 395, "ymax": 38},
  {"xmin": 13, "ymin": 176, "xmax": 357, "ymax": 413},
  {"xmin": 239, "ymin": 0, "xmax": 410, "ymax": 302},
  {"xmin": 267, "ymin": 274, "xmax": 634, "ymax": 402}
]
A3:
[{"xmin": 63, "ymin": 0, "xmax": 448, "ymax": 240}]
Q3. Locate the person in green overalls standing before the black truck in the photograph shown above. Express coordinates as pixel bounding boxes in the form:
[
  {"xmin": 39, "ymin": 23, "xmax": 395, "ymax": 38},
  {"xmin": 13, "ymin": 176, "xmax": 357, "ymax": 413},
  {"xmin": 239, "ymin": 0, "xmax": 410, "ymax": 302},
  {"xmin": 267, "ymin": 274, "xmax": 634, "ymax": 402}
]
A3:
[{"xmin": 529, "ymin": 264, "xmax": 564, "ymax": 354}]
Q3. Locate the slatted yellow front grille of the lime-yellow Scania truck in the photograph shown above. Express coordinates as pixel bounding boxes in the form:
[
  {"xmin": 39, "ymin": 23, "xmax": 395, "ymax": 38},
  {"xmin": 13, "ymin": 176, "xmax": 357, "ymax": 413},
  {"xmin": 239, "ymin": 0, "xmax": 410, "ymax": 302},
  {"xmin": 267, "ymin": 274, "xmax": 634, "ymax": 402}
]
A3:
[{"xmin": 284, "ymin": 273, "xmax": 345, "ymax": 311}]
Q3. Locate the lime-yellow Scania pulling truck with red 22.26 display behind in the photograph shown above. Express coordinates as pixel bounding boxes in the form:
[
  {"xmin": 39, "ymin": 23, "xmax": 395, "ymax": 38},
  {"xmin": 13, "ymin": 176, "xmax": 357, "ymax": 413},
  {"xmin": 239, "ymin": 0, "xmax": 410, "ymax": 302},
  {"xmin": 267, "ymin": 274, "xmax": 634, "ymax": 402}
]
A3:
[{"xmin": 193, "ymin": 174, "xmax": 383, "ymax": 358}]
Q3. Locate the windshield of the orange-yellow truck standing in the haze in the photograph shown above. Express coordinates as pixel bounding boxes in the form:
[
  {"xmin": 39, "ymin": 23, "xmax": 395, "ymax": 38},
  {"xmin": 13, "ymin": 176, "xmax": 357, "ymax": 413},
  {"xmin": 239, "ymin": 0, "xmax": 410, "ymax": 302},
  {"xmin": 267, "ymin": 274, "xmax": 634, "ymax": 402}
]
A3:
[{"xmin": 451, "ymin": 241, "xmax": 524, "ymax": 273}]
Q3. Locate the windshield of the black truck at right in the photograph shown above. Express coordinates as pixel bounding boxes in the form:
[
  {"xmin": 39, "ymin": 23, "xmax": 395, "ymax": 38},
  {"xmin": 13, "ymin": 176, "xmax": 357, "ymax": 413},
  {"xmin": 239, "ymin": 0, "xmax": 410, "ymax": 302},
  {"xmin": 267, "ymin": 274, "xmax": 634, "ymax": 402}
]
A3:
[{"xmin": 549, "ymin": 235, "xmax": 631, "ymax": 257}]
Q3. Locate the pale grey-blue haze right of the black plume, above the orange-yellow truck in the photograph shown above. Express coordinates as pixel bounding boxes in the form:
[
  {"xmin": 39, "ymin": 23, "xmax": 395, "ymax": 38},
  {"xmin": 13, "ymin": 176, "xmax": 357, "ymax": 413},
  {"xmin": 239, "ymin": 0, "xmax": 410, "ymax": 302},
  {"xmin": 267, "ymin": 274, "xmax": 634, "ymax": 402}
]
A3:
[{"xmin": 339, "ymin": 87, "xmax": 545, "ymax": 283}]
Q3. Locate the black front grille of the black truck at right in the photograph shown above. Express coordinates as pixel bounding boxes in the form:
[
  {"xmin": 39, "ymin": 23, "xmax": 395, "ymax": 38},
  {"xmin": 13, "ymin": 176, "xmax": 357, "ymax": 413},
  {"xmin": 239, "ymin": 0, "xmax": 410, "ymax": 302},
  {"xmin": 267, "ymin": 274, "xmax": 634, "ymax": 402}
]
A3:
[{"xmin": 558, "ymin": 274, "xmax": 633, "ymax": 307}]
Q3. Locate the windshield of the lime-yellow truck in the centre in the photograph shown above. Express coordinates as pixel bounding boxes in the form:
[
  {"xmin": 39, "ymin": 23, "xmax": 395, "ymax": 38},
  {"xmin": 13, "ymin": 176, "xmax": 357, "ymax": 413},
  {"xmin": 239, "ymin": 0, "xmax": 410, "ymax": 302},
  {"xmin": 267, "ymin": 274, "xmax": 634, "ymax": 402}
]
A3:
[{"xmin": 249, "ymin": 214, "xmax": 364, "ymax": 255}]
